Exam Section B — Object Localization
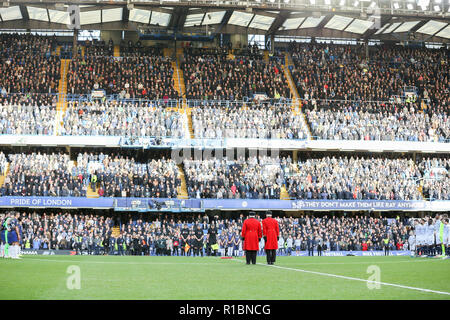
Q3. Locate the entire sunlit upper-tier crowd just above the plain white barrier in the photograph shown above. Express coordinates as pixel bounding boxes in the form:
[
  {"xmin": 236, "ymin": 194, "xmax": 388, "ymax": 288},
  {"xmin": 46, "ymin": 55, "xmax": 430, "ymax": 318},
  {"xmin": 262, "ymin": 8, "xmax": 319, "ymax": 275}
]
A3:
[{"xmin": 0, "ymin": 94, "xmax": 450, "ymax": 142}]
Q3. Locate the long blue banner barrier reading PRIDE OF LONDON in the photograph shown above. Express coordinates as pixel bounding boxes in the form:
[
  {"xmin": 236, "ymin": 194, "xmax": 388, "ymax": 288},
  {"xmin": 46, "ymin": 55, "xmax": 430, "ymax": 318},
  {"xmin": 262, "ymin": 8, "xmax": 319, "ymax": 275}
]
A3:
[{"xmin": 0, "ymin": 196, "xmax": 450, "ymax": 212}]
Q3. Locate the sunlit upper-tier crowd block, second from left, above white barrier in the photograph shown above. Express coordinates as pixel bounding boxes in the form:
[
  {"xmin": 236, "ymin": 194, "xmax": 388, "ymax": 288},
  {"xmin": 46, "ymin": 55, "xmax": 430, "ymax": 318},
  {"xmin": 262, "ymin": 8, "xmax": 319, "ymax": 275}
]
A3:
[{"xmin": 62, "ymin": 100, "xmax": 185, "ymax": 138}]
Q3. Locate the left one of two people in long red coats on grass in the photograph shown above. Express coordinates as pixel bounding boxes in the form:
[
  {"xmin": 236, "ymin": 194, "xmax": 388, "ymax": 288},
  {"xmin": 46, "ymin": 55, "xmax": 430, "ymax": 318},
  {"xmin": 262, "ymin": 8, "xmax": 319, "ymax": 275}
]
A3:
[{"xmin": 241, "ymin": 211, "xmax": 262, "ymax": 264}]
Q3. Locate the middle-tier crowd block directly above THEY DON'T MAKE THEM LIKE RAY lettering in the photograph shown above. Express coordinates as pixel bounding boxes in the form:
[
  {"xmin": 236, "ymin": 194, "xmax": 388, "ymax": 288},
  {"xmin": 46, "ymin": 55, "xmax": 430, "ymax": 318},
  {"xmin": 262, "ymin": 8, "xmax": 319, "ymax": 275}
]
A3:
[{"xmin": 285, "ymin": 156, "xmax": 422, "ymax": 200}]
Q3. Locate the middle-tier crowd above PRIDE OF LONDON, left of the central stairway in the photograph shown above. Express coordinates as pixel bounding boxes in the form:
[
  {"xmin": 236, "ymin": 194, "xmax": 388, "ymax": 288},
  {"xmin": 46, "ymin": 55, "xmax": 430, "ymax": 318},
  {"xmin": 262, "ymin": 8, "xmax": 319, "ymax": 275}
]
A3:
[{"xmin": 0, "ymin": 152, "xmax": 181, "ymax": 198}]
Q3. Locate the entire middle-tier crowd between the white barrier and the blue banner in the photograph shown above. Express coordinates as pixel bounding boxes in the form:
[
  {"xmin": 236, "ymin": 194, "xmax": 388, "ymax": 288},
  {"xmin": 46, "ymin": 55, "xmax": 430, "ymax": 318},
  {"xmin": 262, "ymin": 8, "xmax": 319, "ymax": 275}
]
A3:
[{"xmin": 0, "ymin": 152, "xmax": 450, "ymax": 200}]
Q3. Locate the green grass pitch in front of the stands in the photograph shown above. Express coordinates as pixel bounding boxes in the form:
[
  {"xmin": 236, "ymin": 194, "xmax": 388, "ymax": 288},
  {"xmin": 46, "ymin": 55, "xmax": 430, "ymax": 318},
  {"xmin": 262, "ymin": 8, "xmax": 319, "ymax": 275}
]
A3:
[{"xmin": 0, "ymin": 256, "xmax": 450, "ymax": 300}]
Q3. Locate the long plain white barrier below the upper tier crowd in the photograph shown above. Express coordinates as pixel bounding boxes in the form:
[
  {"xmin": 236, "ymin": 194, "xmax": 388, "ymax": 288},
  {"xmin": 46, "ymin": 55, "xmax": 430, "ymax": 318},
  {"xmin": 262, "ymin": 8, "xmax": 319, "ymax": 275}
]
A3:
[{"xmin": 0, "ymin": 135, "xmax": 450, "ymax": 153}]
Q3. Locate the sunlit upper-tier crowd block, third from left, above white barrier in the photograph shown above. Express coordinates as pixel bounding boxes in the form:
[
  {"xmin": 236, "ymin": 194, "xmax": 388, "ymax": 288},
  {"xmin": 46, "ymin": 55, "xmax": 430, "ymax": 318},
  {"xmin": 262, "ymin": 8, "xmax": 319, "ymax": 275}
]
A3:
[{"xmin": 192, "ymin": 103, "xmax": 307, "ymax": 139}]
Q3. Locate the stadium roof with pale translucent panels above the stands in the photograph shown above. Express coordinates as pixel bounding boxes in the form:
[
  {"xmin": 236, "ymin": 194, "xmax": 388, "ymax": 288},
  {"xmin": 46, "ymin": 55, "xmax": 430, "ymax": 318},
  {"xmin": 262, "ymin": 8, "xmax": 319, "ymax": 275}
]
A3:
[{"xmin": 0, "ymin": 0, "xmax": 450, "ymax": 42}]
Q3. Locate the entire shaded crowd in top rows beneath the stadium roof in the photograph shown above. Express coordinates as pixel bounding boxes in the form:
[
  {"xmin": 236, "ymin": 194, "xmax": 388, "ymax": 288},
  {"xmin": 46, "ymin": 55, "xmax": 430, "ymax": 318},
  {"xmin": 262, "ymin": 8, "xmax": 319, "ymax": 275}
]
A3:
[{"xmin": 0, "ymin": 34, "xmax": 450, "ymax": 108}]
